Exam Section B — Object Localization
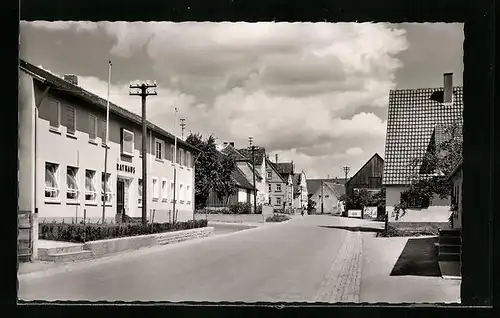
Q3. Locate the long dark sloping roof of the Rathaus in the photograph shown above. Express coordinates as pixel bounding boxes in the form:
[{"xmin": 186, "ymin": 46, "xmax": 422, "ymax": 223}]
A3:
[{"xmin": 19, "ymin": 59, "xmax": 200, "ymax": 152}]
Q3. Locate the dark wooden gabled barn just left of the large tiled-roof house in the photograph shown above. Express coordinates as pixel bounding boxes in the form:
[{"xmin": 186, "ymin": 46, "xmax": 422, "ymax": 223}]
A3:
[{"xmin": 345, "ymin": 153, "xmax": 384, "ymax": 217}]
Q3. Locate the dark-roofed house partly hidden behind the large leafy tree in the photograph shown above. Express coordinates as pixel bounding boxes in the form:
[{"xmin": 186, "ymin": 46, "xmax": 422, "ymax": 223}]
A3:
[{"xmin": 205, "ymin": 152, "xmax": 253, "ymax": 209}]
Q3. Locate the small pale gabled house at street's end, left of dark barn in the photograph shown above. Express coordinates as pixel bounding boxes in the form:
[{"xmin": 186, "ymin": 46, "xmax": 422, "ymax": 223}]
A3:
[{"xmin": 309, "ymin": 182, "xmax": 345, "ymax": 214}]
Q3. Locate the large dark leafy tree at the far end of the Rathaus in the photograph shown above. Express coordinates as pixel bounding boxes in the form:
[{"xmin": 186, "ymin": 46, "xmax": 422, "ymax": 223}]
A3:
[{"xmin": 186, "ymin": 133, "xmax": 236, "ymax": 209}]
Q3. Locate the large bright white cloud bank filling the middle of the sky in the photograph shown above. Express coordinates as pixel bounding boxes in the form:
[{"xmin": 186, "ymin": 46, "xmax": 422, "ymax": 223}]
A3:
[{"xmin": 22, "ymin": 22, "xmax": 409, "ymax": 179}]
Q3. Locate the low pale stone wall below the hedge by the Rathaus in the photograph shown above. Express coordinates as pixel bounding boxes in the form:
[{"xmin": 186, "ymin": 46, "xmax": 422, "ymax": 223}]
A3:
[{"xmin": 84, "ymin": 227, "xmax": 214, "ymax": 257}]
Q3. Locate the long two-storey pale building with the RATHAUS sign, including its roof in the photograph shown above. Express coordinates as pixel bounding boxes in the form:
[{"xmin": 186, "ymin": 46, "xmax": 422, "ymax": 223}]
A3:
[{"xmin": 19, "ymin": 61, "xmax": 198, "ymax": 234}]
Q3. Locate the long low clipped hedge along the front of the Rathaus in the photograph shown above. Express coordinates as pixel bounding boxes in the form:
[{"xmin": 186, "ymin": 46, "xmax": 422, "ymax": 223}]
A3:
[{"xmin": 38, "ymin": 220, "xmax": 207, "ymax": 243}]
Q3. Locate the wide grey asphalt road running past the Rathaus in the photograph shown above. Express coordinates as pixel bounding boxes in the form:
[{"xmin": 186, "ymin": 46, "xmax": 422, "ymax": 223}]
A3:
[{"xmin": 19, "ymin": 216, "xmax": 356, "ymax": 302}]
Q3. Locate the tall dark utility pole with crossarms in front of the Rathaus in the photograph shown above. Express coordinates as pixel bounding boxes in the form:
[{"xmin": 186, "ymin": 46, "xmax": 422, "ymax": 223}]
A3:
[{"xmin": 129, "ymin": 81, "xmax": 158, "ymax": 225}]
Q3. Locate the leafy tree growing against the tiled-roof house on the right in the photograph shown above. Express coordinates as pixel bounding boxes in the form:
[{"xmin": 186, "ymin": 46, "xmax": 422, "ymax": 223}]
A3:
[{"xmin": 394, "ymin": 122, "xmax": 463, "ymax": 219}]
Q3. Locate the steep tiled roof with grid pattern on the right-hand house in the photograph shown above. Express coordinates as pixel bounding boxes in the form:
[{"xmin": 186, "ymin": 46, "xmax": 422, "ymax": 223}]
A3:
[{"xmin": 382, "ymin": 86, "xmax": 463, "ymax": 185}]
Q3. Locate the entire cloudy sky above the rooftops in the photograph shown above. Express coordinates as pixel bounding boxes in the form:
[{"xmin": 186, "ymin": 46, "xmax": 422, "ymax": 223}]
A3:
[{"xmin": 20, "ymin": 21, "xmax": 464, "ymax": 178}]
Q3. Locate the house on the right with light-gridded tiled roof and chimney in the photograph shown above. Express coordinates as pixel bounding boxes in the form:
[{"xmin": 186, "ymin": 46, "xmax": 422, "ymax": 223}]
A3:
[{"xmin": 382, "ymin": 73, "xmax": 463, "ymax": 222}]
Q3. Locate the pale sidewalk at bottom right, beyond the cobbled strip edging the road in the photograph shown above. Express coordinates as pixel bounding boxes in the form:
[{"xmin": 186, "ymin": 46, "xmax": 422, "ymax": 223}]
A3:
[{"xmin": 360, "ymin": 233, "xmax": 460, "ymax": 303}]
